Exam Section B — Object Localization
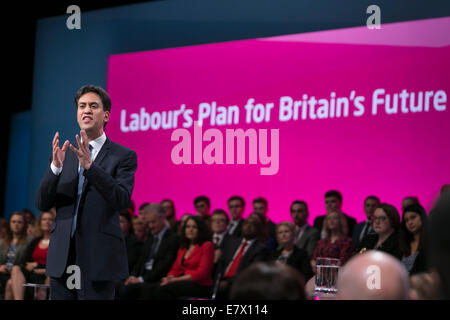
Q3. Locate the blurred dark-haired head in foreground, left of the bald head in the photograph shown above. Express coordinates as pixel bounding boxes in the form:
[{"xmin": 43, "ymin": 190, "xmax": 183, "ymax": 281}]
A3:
[{"xmin": 230, "ymin": 262, "xmax": 305, "ymax": 300}]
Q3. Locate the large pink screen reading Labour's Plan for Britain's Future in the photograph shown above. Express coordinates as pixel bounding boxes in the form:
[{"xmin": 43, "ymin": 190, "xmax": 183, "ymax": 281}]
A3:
[{"xmin": 107, "ymin": 18, "xmax": 450, "ymax": 223}]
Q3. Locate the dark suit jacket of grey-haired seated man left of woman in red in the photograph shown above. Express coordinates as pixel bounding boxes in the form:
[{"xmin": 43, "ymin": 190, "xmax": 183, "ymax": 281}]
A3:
[{"xmin": 131, "ymin": 229, "xmax": 179, "ymax": 282}]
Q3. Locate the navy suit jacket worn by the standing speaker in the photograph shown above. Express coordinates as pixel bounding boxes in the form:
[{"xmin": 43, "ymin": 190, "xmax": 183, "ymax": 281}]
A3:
[{"xmin": 36, "ymin": 138, "xmax": 137, "ymax": 281}]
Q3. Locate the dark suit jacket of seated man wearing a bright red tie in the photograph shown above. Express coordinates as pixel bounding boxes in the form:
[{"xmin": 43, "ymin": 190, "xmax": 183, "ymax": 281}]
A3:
[{"xmin": 214, "ymin": 238, "xmax": 270, "ymax": 280}]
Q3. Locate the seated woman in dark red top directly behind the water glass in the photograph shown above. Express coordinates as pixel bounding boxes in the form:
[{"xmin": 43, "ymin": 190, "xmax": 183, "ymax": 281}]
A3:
[{"xmin": 311, "ymin": 212, "xmax": 353, "ymax": 273}]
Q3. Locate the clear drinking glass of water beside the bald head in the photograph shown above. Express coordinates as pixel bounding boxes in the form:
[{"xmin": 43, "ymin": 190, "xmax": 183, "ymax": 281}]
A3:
[{"xmin": 314, "ymin": 258, "xmax": 341, "ymax": 294}]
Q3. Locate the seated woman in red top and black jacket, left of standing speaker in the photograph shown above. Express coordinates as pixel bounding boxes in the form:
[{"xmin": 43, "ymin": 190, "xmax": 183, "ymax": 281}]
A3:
[{"xmin": 5, "ymin": 212, "xmax": 54, "ymax": 300}]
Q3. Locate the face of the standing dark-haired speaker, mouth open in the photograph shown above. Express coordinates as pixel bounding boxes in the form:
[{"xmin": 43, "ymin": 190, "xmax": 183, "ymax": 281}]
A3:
[{"xmin": 77, "ymin": 92, "xmax": 109, "ymax": 135}]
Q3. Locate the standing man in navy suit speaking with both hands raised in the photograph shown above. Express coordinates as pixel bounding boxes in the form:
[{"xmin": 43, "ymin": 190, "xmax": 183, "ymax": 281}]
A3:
[{"xmin": 36, "ymin": 85, "xmax": 137, "ymax": 300}]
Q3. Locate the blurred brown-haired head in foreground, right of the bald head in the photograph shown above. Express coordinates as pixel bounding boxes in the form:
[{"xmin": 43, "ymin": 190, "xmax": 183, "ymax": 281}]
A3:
[{"xmin": 409, "ymin": 272, "xmax": 441, "ymax": 300}]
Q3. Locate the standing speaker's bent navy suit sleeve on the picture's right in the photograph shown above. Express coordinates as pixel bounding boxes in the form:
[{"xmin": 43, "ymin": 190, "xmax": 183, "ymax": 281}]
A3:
[{"xmin": 84, "ymin": 151, "xmax": 137, "ymax": 211}]
